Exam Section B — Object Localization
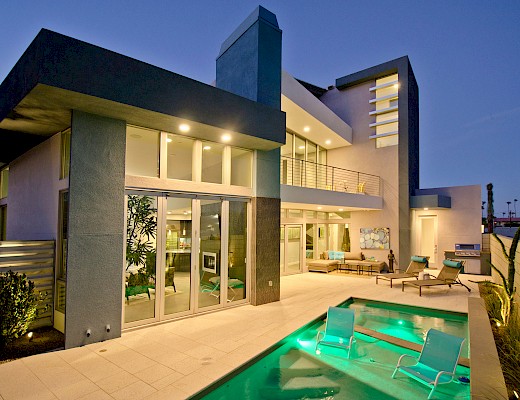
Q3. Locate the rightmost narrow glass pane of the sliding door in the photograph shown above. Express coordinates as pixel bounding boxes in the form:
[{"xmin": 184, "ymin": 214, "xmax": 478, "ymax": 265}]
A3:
[{"xmin": 227, "ymin": 201, "xmax": 247, "ymax": 302}]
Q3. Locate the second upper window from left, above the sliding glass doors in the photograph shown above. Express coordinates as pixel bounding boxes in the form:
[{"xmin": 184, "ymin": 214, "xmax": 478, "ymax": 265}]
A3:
[{"xmin": 166, "ymin": 134, "xmax": 195, "ymax": 181}]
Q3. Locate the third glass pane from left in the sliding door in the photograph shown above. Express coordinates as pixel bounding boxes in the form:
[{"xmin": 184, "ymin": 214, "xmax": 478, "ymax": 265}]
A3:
[{"xmin": 198, "ymin": 200, "xmax": 222, "ymax": 309}]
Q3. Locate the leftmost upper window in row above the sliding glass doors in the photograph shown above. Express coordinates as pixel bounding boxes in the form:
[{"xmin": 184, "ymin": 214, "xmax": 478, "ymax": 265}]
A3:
[{"xmin": 126, "ymin": 126, "xmax": 159, "ymax": 178}]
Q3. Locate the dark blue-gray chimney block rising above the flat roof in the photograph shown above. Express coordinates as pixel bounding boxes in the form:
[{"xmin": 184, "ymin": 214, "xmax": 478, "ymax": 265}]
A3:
[{"xmin": 216, "ymin": 7, "xmax": 282, "ymax": 111}]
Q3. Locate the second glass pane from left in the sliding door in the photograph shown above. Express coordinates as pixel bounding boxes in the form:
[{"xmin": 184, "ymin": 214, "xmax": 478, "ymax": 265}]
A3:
[{"xmin": 163, "ymin": 197, "xmax": 192, "ymax": 315}]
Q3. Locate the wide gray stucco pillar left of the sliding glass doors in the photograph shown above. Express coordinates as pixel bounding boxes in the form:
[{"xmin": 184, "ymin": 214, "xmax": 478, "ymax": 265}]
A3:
[{"xmin": 65, "ymin": 111, "xmax": 126, "ymax": 348}]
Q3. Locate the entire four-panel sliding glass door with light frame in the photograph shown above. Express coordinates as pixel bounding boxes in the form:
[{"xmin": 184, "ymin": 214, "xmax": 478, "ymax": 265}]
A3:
[{"xmin": 123, "ymin": 192, "xmax": 249, "ymax": 327}]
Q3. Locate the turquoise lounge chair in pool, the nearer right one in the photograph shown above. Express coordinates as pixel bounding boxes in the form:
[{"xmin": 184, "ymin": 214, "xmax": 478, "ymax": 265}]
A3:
[{"xmin": 392, "ymin": 329, "xmax": 465, "ymax": 399}]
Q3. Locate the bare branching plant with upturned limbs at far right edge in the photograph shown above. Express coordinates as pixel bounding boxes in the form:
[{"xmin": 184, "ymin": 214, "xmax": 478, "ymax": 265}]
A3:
[{"xmin": 491, "ymin": 229, "xmax": 520, "ymax": 325}]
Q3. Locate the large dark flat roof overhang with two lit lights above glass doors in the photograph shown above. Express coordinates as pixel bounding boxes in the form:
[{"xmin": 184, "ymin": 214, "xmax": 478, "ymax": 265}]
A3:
[{"xmin": 0, "ymin": 29, "xmax": 285, "ymax": 162}]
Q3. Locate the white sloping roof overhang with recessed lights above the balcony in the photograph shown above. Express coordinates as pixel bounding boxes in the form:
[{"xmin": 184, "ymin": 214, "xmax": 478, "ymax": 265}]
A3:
[{"xmin": 282, "ymin": 71, "xmax": 352, "ymax": 150}]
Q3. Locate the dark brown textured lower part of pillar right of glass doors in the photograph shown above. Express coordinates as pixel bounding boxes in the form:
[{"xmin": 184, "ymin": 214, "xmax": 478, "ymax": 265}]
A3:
[{"xmin": 251, "ymin": 197, "xmax": 280, "ymax": 306}]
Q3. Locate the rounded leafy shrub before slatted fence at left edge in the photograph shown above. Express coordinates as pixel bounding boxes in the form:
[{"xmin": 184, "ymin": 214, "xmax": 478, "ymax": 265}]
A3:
[{"xmin": 0, "ymin": 271, "xmax": 41, "ymax": 348}]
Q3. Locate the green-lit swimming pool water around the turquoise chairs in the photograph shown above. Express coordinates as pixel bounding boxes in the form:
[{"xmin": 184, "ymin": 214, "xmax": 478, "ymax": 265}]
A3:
[{"xmin": 193, "ymin": 299, "xmax": 470, "ymax": 400}]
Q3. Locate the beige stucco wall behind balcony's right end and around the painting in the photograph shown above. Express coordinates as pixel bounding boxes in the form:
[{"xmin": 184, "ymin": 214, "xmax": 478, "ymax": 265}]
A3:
[{"xmin": 321, "ymin": 81, "xmax": 402, "ymax": 263}]
